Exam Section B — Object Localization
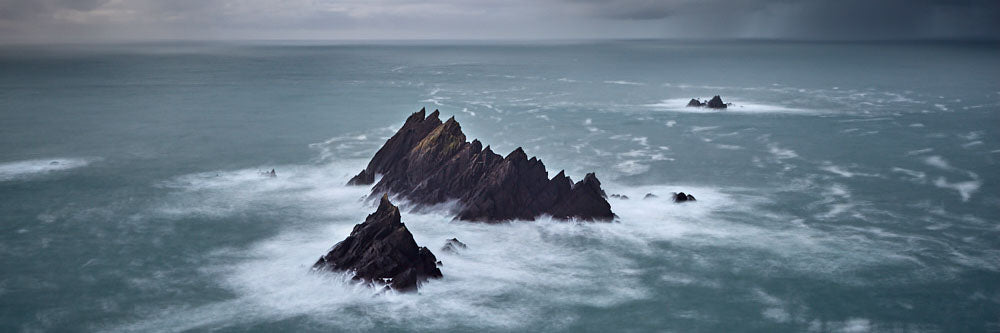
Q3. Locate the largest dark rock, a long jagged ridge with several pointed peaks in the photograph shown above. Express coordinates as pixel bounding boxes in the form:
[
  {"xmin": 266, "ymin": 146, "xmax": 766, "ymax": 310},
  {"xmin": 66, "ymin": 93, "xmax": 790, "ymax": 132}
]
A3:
[{"xmin": 348, "ymin": 109, "xmax": 614, "ymax": 222}]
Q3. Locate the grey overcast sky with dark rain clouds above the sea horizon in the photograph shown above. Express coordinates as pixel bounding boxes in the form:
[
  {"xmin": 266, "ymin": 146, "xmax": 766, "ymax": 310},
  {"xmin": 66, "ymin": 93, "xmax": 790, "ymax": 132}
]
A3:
[{"xmin": 0, "ymin": 0, "xmax": 1000, "ymax": 42}]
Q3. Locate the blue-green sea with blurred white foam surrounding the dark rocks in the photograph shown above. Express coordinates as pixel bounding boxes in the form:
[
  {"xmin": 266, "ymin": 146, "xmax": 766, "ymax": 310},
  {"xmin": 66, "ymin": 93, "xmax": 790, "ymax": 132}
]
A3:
[{"xmin": 0, "ymin": 40, "xmax": 1000, "ymax": 332}]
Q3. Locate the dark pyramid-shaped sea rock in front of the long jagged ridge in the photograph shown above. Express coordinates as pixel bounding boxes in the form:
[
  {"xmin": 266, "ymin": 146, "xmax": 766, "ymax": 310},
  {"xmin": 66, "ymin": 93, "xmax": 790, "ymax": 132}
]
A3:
[{"xmin": 312, "ymin": 196, "xmax": 441, "ymax": 291}]
